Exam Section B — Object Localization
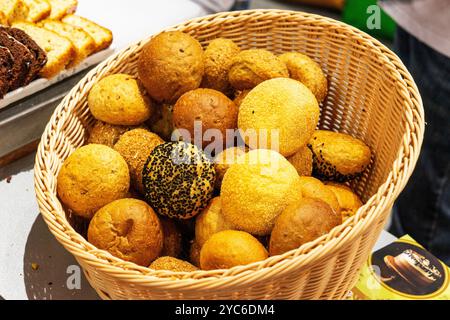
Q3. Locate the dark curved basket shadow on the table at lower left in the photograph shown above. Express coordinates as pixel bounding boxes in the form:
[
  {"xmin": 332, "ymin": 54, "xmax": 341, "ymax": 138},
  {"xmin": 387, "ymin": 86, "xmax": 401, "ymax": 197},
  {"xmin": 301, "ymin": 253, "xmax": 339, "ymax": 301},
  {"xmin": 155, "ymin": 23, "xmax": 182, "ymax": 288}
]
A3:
[{"xmin": 23, "ymin": 215, "xmax": 99, "ymax": 300}]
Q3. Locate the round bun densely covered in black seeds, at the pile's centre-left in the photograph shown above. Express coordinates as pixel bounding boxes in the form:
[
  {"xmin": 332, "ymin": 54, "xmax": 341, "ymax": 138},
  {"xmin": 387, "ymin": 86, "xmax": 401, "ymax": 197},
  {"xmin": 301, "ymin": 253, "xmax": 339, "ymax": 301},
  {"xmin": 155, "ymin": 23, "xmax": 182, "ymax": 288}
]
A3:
[{"xmin": 143, "ymin": 142, "xmax": 216, "ymax": 219}]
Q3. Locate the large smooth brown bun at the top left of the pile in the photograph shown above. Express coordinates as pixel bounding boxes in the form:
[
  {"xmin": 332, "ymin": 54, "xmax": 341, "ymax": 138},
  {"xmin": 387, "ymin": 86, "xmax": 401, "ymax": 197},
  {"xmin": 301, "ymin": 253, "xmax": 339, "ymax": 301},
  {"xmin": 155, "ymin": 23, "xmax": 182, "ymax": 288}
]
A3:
[{"xmin": 138, "ymin": 31, "xmax": 205, "ymax": 103}]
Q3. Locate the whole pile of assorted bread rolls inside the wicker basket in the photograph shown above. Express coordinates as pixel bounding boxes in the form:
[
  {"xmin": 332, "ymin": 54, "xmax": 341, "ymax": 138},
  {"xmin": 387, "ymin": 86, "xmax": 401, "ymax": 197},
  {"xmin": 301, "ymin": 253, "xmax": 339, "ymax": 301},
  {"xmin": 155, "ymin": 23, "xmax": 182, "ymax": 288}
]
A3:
[{"xmin": 57, "ymin": 31, "xmax": 371, "ymax": 272}]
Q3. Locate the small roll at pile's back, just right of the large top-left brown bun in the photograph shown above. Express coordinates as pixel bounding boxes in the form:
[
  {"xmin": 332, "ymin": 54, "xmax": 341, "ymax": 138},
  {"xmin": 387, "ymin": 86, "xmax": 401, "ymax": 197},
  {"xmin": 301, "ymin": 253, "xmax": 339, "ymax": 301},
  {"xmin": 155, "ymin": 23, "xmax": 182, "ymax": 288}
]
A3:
[{"xmin": 201, "ymin": 38, "xmax": 241, "ymax": 95}]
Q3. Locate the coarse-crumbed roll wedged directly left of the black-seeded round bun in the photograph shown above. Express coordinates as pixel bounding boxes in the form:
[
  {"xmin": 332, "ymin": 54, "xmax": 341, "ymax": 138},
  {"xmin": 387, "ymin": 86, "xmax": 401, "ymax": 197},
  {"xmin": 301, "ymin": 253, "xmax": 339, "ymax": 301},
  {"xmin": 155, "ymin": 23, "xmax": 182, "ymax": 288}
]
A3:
[{"xmin": 114, "ymin": 128, "xmax": 164, "ymax": 193}]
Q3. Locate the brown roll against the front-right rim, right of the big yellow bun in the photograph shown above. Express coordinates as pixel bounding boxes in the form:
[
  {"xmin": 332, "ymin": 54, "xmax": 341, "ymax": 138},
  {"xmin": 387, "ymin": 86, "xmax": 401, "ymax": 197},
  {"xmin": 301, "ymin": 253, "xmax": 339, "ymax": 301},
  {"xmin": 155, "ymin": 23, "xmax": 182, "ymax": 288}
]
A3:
[{"xmin": 269, "ymin": 198, "xmax": 341, "ymax": 256}]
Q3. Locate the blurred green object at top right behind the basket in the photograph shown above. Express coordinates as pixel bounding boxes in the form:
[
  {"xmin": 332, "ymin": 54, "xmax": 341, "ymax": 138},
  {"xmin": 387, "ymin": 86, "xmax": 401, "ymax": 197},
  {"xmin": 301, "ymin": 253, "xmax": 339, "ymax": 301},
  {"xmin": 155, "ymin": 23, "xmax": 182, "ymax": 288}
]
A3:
[{"xmin": 342, "ymin": 0, "xmax": 397, "ymax": 40}]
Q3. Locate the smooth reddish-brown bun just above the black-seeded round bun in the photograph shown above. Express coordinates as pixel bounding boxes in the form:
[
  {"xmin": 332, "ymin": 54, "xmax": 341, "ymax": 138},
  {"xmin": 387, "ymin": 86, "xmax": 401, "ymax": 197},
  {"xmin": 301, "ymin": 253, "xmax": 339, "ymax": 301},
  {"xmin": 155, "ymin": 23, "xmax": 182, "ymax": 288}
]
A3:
[{"xmin": 173, "ymin": 89, "xmax": 238, "ymax": 148}]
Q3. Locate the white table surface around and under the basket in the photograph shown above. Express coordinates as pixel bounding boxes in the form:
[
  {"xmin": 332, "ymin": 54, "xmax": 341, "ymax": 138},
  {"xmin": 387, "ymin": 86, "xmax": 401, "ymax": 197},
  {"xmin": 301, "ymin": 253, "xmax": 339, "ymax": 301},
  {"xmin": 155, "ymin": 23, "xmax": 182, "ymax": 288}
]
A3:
[{"xmin": 0, "ymin": 0, "xmax": 395, "ymax": 300}]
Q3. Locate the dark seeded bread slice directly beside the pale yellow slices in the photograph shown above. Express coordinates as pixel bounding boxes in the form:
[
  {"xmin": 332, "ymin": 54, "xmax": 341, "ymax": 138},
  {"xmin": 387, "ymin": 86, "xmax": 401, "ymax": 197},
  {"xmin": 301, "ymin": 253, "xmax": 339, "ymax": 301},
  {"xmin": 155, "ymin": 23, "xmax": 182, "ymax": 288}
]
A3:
[{"xmin": 8, "ymin": 28, "xmax": 47, "ymax": 86}]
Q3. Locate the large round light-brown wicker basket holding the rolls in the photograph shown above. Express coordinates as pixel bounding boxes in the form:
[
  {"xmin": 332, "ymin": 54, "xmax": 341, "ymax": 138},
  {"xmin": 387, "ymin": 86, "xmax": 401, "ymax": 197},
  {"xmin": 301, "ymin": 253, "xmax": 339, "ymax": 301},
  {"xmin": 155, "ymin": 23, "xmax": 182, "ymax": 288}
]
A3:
[{"xmin": 35, "ymin": 10, "xmax": 424, "ymax": 299}]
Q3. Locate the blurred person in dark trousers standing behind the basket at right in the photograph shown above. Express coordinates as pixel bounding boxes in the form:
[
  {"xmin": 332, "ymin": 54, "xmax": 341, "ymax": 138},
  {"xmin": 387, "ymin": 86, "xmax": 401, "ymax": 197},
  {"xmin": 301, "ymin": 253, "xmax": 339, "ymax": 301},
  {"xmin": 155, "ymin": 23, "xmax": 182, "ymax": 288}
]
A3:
[{"xmin": 379, "ymin": 0, "xmax": 450, "ymax": 264}]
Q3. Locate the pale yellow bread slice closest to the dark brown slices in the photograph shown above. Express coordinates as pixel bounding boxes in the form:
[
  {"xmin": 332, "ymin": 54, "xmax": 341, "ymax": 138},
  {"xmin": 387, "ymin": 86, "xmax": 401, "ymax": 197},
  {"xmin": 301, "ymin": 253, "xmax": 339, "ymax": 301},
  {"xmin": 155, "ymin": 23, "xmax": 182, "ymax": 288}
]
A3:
[{"xmin": 13, "ymin": 22, "xmax": 76, "ymax": 78}]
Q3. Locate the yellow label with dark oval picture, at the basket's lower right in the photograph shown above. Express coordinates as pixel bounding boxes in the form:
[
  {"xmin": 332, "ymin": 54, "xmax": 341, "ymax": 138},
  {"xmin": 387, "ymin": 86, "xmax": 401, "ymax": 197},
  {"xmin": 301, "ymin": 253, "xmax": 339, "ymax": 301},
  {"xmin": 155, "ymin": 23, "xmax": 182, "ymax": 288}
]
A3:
[{"xmin": 352, "ymin": 236, "xmax": 450, "ymax": 300}]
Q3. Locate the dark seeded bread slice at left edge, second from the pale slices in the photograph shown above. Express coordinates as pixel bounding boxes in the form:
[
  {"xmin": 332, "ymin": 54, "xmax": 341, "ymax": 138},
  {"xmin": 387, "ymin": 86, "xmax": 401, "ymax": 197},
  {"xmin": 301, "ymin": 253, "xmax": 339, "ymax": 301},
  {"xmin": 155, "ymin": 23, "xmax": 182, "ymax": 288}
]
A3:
[{"xmin": 0, "ymin": 30, "xmax": 34, "ymax": 91}]
